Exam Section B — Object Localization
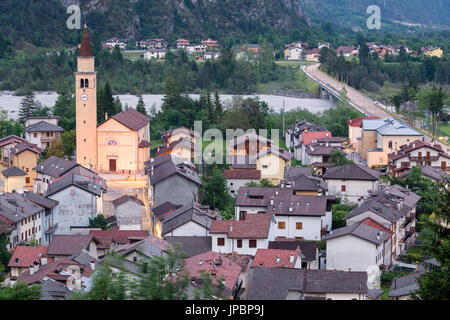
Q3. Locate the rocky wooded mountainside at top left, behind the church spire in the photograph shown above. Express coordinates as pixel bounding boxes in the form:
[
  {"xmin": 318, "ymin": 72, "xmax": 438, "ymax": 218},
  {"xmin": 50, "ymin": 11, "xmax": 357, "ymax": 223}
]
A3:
[{"xmin": 0, "ymin": 0, "xmax": 308, "ymax": 46}]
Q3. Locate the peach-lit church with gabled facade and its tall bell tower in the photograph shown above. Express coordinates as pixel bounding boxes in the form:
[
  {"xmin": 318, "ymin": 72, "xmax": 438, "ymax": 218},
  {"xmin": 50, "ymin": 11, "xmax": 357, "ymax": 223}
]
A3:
[{"xmin": 75, "ymin": 25, "xmax": 150, "ymax": 174}]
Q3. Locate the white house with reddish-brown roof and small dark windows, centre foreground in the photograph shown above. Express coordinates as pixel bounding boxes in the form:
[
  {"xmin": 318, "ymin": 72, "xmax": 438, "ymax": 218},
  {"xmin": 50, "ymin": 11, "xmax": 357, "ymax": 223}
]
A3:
[{"xmin": 209, "ymin": 214, "xmax": 275, "ymax": 256}]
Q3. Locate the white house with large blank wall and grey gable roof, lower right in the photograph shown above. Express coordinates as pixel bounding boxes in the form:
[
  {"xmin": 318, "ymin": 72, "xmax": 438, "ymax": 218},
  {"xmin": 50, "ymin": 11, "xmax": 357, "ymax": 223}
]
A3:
[{"xmin": 322, "ymin": 218, "xmax": 393, "ymax": 271}]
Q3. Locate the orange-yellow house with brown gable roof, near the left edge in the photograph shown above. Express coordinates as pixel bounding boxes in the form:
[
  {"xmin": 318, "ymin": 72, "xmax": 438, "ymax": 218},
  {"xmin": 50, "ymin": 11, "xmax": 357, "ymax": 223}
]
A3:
[{"xmin": 11, "ymin": 142, "xmax": 41, "ymax": 190}]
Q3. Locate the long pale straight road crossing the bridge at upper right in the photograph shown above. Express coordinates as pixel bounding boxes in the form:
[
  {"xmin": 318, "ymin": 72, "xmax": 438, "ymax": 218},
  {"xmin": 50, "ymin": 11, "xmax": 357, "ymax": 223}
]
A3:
[{"xmin": 301, "ymin": 63, "xmax": 434, "ymax": 142}]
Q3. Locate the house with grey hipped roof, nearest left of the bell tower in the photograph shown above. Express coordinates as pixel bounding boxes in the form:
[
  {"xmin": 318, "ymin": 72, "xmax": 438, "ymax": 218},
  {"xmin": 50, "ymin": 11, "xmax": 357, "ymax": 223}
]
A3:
[{"xmin": 25, "ymin": 117, "xmax": 64, "ymax": 150}]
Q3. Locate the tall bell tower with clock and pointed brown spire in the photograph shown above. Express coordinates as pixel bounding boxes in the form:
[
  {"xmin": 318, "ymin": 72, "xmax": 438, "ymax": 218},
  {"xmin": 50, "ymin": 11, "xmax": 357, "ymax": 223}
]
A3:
[{"xmin": 75, "ymin": 24, "xmax": 97, "ymax": 170}]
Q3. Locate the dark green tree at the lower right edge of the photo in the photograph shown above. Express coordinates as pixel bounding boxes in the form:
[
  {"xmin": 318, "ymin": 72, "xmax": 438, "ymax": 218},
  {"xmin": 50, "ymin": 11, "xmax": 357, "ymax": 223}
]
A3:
[{"xmin": 413, "ymin": 178, "xmax": 450, "ymax": 300}]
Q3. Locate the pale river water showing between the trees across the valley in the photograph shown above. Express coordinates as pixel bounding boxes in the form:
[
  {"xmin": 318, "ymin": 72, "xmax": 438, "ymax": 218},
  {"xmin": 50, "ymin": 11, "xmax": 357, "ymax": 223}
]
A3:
[{"xmin": 0, "ymin": 91, "xmax": 334, "ymax": 119}]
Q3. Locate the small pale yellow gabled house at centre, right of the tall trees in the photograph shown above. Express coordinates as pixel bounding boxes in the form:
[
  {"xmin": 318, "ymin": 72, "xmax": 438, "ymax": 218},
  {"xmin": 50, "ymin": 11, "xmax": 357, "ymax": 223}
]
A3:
[{"xmin": 256, "ymin": 148, "xmax": 293, "ymax": 185}]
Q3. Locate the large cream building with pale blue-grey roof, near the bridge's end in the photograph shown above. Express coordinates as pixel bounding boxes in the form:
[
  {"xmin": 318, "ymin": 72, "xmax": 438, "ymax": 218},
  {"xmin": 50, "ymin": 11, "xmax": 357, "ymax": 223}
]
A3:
[{"xmin": 358, "ymin": 117, "xmax": 423, "ymax": 167}]
